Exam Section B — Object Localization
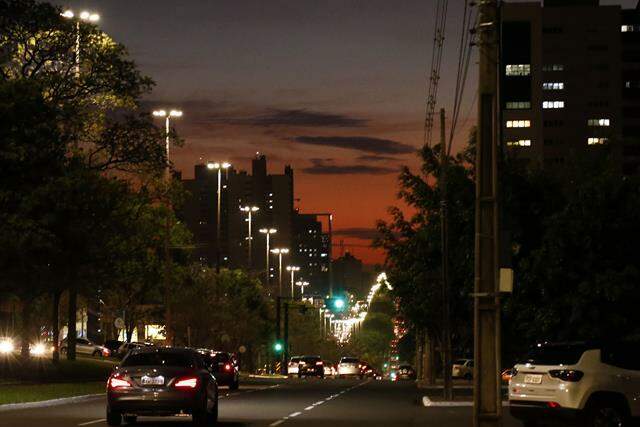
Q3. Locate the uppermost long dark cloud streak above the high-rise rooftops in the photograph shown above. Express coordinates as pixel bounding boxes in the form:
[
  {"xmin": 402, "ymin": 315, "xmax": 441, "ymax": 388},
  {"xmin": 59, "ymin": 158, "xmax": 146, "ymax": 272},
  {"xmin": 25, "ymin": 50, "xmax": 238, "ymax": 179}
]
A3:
[{"xmin": 229, "ymin": 109, "xmax": 367, "ymax": 127}]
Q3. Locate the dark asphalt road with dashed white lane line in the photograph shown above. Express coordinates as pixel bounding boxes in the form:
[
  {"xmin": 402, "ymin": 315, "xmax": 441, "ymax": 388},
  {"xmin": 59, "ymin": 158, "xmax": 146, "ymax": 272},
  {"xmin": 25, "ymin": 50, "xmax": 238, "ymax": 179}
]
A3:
[{"xmin": 0, "ymin": 379, "xmax": 521, "ymax": 427}]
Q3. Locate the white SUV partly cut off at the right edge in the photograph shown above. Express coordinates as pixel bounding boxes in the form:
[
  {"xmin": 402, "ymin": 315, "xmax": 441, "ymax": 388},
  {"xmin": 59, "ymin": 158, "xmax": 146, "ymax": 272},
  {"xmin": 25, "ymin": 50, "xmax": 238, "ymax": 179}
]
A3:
[{"xmin": 509, "ymin": 342, "xmax": 640, "ymax": 427}]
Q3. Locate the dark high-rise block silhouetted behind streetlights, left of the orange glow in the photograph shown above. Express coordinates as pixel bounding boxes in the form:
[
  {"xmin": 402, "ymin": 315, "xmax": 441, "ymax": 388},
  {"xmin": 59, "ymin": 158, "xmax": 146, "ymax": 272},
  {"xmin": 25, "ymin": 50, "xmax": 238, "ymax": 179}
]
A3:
[{"xmin": 182, "ymin": 154, "xmax": 293, "ymax": 274}]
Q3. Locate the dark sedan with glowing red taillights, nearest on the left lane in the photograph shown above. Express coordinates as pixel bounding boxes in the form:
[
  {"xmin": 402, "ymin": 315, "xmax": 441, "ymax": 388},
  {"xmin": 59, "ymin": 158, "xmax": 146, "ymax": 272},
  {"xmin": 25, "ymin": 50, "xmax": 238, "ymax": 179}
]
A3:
[{"xmin": 107, "ymin": 347, "xmax": 218, "ymax": 426}]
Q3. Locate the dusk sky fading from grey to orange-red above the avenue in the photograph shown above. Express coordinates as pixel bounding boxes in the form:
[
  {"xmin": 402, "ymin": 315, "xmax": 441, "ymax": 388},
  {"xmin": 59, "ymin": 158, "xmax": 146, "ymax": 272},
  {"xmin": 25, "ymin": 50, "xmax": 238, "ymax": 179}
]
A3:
[{"xmin": 54, "ymin": 0, "xmax": 636, "ymax": 263}]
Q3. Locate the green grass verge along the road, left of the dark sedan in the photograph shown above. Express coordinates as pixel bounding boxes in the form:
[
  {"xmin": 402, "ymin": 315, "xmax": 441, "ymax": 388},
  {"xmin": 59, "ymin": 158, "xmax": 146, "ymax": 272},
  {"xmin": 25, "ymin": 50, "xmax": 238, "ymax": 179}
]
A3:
[{"xmin": 0, "ymin": 381, "xmax": 105, "ymax": 405}]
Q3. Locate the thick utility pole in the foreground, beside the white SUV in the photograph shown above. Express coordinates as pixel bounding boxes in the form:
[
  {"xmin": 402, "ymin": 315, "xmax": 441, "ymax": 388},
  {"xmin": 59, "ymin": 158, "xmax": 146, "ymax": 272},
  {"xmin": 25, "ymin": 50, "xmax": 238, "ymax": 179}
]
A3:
[{"xmin": 473, "ymin": 0, "xmax": 502, "ymax": 427}]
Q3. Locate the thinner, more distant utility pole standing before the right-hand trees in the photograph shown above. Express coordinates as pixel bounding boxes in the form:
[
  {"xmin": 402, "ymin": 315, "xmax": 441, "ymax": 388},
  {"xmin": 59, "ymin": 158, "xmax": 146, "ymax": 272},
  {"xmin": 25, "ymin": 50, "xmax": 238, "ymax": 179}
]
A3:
[{"xmin": 439, "ymin": 108, "xmax": 453, "ymax": 400}]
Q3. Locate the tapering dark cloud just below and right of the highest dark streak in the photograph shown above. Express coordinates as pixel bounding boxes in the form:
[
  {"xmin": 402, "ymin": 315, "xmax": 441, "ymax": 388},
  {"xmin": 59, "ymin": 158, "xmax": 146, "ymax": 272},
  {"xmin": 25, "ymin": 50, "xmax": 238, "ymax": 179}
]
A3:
[{"xmin": 293, "ymin": 136, "xmax": 416, "ymax": 154}]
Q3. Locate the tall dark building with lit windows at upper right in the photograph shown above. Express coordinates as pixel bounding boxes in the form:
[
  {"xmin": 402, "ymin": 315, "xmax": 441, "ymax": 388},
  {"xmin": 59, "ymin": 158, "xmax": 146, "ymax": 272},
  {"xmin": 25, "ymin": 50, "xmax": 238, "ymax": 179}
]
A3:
[{"xmin": 500, "ymin": 0, "xmax": 640, "ymax": 173}]
